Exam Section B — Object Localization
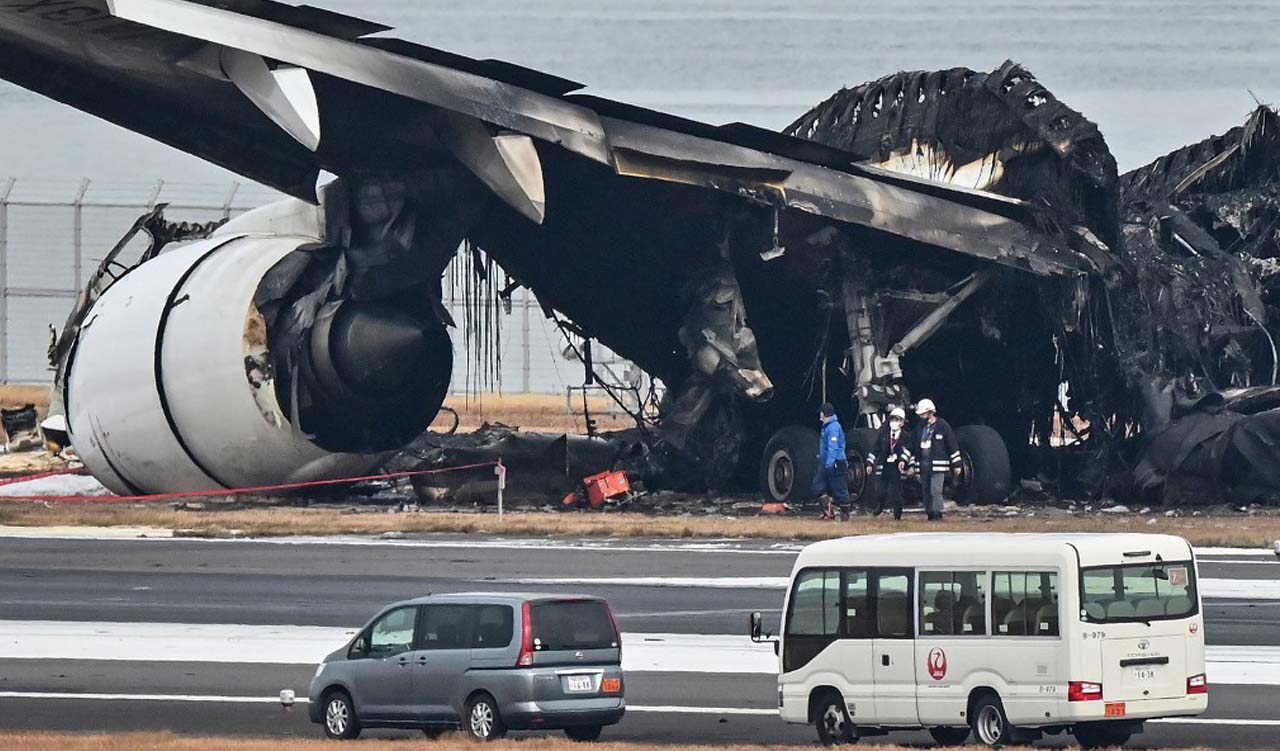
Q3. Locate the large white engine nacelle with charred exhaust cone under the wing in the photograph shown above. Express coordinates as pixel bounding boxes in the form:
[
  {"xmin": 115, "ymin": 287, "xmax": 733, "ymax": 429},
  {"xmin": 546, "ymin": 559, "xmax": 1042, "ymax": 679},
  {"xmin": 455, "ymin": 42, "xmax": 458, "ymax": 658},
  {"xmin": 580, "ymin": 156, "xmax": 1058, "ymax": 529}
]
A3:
[{"xmin": 65, "ymin": 228, "xmax": 452, "ymax": 495}]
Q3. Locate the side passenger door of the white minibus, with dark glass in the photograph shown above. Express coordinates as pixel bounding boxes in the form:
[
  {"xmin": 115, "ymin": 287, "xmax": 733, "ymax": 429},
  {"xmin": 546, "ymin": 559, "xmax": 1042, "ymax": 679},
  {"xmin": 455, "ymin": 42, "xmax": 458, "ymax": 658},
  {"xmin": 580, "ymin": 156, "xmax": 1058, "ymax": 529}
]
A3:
[{"xmin": 872, "ymin": 568, "xmax": 920, "ymax": 725}]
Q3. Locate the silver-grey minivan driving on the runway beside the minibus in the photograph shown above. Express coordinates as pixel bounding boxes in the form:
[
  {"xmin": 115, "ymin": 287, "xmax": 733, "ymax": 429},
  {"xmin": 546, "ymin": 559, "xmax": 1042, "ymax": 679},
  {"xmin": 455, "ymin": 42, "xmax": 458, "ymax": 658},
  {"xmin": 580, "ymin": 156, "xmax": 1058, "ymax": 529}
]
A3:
[{"xmin": 310, "ymin": 594, "xmax": 626, "ymax": 741}]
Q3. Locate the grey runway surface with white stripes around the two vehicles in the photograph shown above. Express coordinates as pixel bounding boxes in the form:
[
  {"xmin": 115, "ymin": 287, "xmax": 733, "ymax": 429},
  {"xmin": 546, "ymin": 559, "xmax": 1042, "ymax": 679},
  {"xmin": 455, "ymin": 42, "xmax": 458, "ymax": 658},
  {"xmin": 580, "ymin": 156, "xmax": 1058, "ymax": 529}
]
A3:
[{"xmin": 0, "ymin": 536, "xmax": 1280, "ymax": 748}]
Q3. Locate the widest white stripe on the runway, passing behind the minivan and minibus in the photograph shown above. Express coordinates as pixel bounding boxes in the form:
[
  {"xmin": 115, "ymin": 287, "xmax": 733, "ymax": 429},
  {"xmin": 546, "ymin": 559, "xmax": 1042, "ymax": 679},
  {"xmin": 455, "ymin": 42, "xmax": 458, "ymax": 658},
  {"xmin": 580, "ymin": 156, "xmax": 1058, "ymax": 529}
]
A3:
[{"xmin": 0, "ymin": 621, "xmax": 1280, "ymax": 686}]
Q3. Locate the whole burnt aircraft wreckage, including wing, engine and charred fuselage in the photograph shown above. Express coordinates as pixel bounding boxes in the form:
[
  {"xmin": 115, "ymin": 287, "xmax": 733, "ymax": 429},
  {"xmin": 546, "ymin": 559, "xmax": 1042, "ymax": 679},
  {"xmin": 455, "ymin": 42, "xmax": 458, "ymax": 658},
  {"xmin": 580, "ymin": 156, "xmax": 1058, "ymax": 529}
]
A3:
[{"xmin": 0, "ymin": 0, "xmax": 1280, "ymax": 502}]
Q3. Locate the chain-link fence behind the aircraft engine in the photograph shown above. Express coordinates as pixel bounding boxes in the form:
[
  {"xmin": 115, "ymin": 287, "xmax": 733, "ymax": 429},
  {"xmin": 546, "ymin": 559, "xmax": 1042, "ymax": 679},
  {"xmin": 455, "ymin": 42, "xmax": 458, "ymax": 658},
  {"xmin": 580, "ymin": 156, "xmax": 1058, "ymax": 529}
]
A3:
[{"xmin": 0, "ymin": 178, "xmax": 635, "ymax": 394}]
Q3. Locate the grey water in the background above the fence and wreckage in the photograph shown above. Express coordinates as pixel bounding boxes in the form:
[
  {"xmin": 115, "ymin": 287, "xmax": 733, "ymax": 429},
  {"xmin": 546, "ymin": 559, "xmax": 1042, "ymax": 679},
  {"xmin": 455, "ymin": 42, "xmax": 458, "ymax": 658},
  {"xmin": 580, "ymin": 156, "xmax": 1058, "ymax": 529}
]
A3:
[{"xmin": 0, "ymin": 0, "xmax": 1280, "ymax": 182}]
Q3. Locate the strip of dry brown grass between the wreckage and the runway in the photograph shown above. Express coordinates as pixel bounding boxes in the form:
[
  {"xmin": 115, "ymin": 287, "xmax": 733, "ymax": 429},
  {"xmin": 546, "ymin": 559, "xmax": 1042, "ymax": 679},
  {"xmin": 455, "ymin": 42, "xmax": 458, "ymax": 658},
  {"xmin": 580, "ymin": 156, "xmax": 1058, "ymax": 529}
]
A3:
[{"xmin": 0, "ymin": 503, "xmax": 1280, "ymax": 548}]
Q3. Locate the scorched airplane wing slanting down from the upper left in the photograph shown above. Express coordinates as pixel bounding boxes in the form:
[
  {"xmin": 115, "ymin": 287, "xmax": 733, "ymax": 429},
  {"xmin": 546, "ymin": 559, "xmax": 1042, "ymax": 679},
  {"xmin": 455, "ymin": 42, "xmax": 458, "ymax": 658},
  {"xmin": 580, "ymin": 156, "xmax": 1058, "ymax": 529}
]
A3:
[{"xmin": 0, "ymin": 0, "xmax": 1098, "ymax": 276}]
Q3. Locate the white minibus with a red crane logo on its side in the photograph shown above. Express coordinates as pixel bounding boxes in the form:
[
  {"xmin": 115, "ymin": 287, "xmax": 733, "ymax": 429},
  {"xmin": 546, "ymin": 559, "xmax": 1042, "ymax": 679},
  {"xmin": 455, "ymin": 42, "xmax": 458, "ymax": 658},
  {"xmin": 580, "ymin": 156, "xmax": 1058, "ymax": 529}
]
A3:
[{"xmin": 751, "ymin": 534, "xmax": 1208, "ymax": 747}]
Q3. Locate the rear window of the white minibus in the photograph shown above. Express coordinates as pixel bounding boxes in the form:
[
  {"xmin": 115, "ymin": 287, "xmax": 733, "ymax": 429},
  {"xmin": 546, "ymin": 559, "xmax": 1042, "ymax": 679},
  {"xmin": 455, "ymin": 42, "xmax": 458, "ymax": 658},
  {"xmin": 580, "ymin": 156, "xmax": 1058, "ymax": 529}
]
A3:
[{"xmin": 1080, "ymin": 560, "xmax": 1197, "ymax": 623}]
